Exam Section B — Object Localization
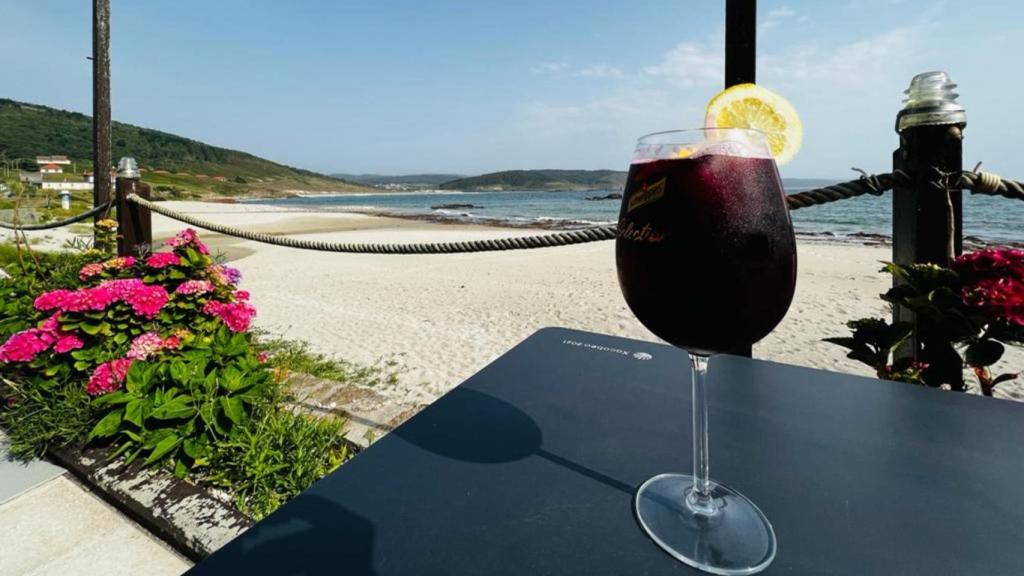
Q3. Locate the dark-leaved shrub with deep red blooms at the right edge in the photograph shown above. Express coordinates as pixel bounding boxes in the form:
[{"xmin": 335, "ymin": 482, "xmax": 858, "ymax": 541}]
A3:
[{"xmin": 825, "ymin": 248, "xmax": 1024, "ymax": 396}]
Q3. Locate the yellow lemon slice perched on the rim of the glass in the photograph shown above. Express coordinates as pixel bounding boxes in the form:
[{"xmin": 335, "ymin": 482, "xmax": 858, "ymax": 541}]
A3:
[{"xmin": 705, "ymin": 84, "xmax": 804, "ymax": 166}]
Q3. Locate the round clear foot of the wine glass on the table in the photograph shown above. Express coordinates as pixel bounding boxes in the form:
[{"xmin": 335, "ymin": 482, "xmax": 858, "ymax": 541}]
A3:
[{"xmin": 636, "ymin": 474, "xmax": 775, "ymax": 575}]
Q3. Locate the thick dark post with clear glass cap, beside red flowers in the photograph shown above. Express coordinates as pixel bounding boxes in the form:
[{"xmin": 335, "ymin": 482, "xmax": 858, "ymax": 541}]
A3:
[{"xmin": 893, "ymin": 72, "xmax": 967, "ymax": 389}]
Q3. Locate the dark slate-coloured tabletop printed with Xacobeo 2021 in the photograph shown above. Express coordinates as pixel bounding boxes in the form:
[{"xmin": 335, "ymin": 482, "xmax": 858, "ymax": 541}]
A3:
[{"xmin": 190, "ymin": 328, "xmax": 1024, "ymax": 576}]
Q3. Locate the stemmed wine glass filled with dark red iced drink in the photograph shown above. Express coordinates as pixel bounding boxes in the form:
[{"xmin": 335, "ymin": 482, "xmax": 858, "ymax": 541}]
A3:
[{"xmin": 615, "ymin": 128, "xmax": 797, "ymax": 574}]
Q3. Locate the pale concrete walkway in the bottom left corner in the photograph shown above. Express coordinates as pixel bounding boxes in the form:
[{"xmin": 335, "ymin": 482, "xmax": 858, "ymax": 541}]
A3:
[{"xmin": 0, "ymin": 433, "xmax": 191, "ymax": 576}]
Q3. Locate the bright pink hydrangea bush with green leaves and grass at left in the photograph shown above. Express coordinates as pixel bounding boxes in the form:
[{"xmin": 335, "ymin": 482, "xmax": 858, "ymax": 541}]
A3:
[{"xmin": 0, "ymin": 230, "xmax": 393, "ymax": 518}]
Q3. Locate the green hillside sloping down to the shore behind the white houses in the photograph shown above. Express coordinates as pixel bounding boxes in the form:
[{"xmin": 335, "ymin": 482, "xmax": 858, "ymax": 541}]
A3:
[{"xmin": 0, "ymin": 98, "xmax": 367, "ymax": 196}]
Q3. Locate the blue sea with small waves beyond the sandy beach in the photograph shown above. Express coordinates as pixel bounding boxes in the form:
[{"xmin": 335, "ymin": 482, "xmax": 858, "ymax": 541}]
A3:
[{"xmin": 258, "ymin": 188, "xmax": 1024, "ymax": 244}]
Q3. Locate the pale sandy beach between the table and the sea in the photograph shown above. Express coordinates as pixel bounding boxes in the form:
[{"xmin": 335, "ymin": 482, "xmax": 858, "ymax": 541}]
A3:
[{"xmin": 4, "ymin": 202, "xmax": 1024, "ymax": 404}]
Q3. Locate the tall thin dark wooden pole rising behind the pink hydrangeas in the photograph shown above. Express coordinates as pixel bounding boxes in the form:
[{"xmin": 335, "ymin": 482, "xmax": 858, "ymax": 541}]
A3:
[{"xmin": 92, "ymin": 0, "xmax": 111, "ymax": 243}]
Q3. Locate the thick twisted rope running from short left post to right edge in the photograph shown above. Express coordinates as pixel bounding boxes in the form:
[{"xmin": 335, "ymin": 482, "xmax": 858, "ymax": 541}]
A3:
[{"xmin": 128, "ymin": 168, "xmax": 1024, "ymax": 254}]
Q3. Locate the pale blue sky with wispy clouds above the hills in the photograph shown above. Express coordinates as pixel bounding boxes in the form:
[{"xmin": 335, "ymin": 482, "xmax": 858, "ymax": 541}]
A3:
[{"xmin": 0, "ymin": 0, "xmax": 1024, "ymax": 177}]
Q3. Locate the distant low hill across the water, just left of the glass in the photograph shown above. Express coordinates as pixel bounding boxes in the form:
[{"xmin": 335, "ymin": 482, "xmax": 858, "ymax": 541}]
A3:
[{"xmin": 439, "ymin": 170, "xmax": 626, "ymax": 191}]
